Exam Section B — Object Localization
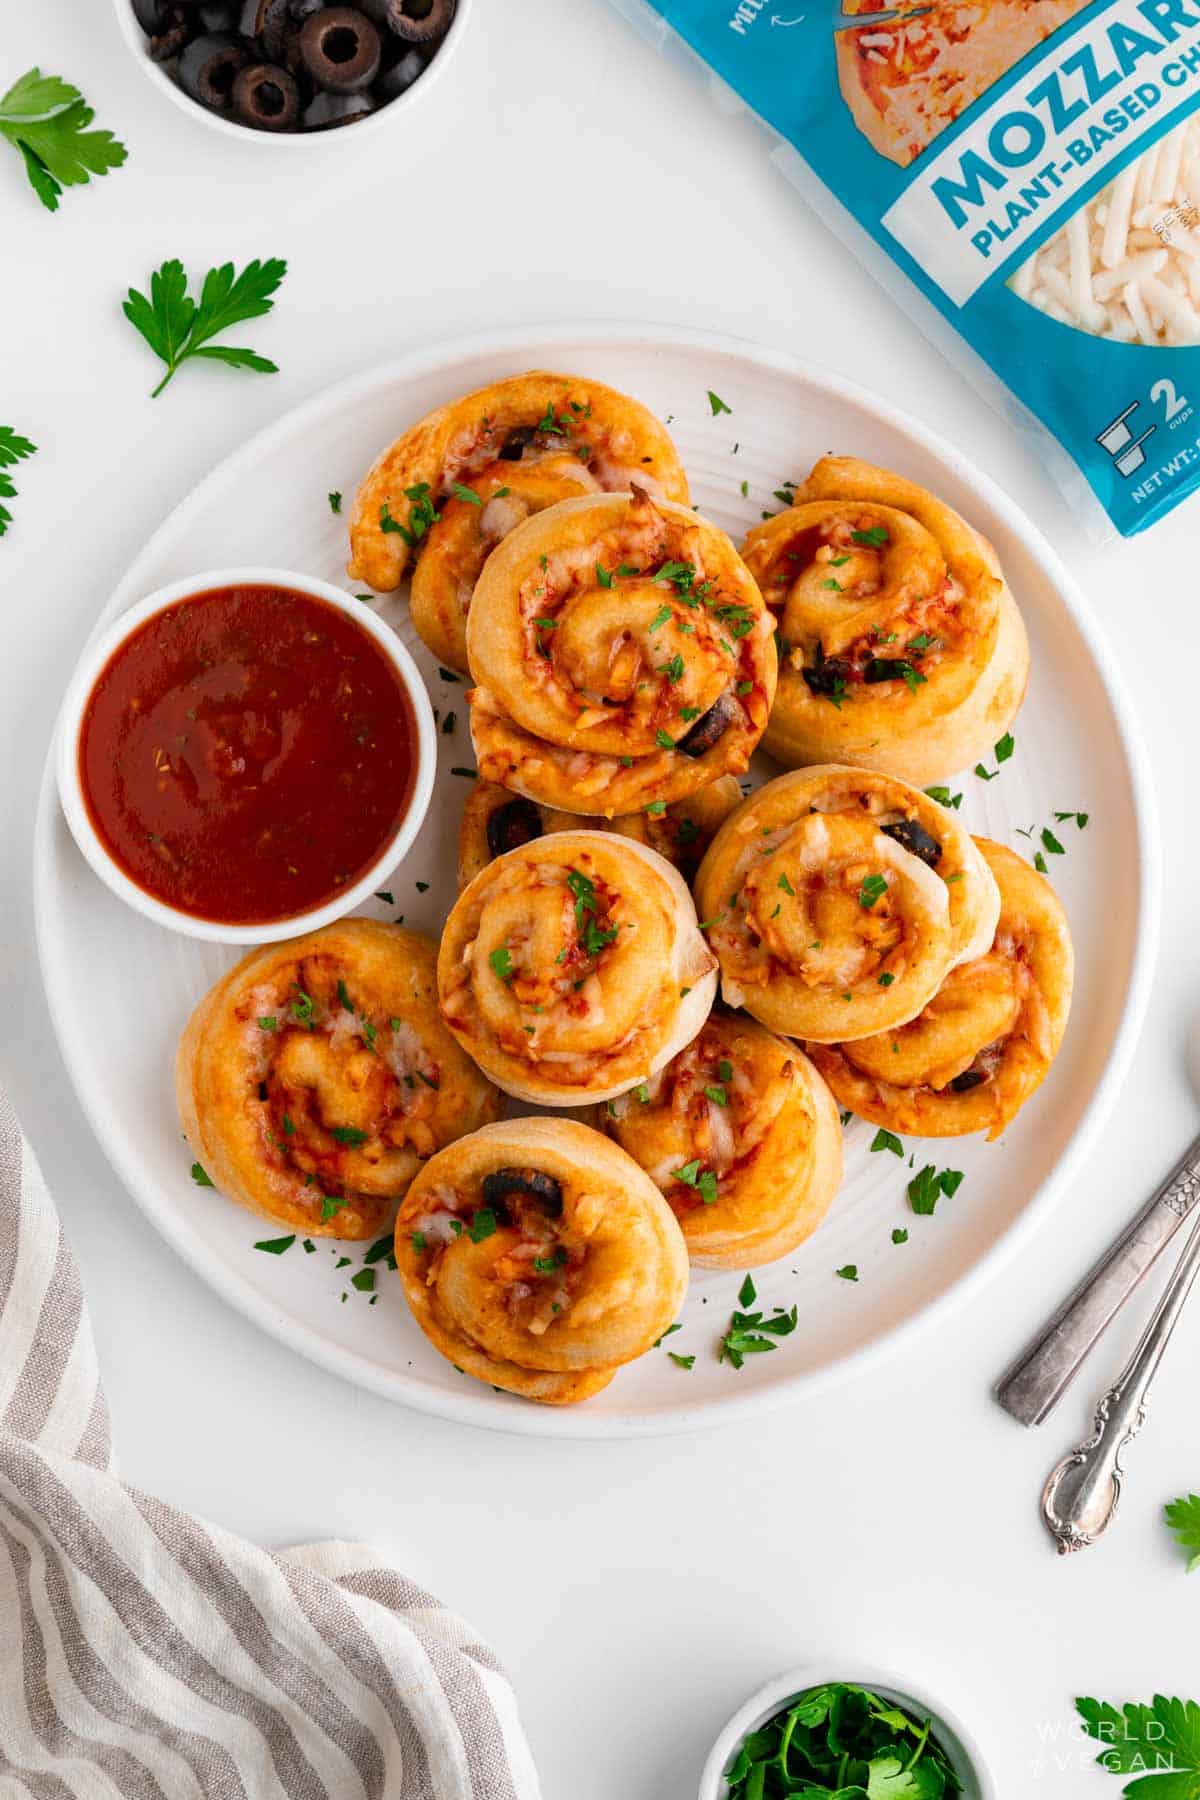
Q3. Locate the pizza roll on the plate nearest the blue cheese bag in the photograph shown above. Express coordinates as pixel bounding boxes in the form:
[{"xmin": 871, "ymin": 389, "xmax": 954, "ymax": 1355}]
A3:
[{"xmin": 743, "ymin": 457, "xmax": 1029, "ymax": 787}]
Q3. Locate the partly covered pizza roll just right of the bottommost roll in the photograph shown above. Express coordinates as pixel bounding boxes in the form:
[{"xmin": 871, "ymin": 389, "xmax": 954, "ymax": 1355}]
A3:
[{"xmin": 597, "ymin": 1012, "xmax": 842, "ymax": 1269}]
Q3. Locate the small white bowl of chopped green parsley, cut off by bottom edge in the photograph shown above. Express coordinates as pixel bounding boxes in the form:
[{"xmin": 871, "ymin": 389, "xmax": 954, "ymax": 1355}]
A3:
[{"xmin": 700, "ymin": 1661, "xmax": 997, "ymax": 1800}]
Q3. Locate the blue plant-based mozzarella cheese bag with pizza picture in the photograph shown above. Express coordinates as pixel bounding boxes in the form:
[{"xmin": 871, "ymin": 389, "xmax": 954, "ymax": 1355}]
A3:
[{"xmin": 615, "ymin": 0, "xmax": 1200, "ymax": 536}]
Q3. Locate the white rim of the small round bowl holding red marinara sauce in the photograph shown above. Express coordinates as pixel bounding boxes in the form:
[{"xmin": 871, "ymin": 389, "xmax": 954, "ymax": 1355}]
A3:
[{"xmin": 54, "ymin": 569, "xmax": 437, "ymax": 943}]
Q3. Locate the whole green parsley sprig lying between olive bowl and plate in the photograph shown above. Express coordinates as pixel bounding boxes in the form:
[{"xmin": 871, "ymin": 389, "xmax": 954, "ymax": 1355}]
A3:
[{"xmin": 122, "ymin": 257, "xmax": 288, "ymax": 400}]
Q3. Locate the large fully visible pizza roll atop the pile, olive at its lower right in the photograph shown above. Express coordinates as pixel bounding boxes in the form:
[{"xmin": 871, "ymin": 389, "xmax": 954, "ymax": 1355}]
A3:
[{"xmin": 466, "ymin": 488, "xmax": 775, "ymax": 819}]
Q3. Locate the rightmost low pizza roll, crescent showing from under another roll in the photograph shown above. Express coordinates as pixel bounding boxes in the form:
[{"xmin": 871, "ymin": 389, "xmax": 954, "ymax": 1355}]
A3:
[{"xmin": 811, "ymin": 837, "xmax": 1074, "ymax": 1138}]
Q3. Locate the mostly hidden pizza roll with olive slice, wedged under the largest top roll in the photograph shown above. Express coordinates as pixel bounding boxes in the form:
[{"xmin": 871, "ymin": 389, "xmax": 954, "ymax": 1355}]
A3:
[{"xmin": 459, "ymin": 776, "xmax": 741, "ymax": 889}]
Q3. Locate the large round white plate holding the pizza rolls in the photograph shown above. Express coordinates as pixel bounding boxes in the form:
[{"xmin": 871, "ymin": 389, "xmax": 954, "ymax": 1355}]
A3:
[{"xmin": 34, "ymin": 326, "xmax": 1159, "ymax": 1436}]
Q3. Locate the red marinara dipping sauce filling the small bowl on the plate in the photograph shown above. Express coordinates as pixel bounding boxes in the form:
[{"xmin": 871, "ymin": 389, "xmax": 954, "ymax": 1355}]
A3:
[{"xmin": 79, "ymin": 587, "xmax": 417, "ymax": 925}]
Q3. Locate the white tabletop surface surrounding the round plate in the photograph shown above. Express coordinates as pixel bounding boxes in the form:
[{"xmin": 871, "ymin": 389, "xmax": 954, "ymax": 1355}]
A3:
[{"xmin": 0, "ymin": 0, "xmax": 1200, "ymax": 1800}]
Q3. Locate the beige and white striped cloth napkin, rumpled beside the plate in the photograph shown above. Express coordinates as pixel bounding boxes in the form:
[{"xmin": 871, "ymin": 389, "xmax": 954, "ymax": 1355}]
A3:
[{"xmin": 0, "ymin": 1093, "xmax": 540, "ymax": 1800}]
